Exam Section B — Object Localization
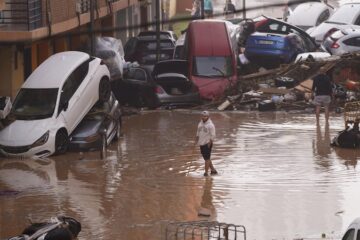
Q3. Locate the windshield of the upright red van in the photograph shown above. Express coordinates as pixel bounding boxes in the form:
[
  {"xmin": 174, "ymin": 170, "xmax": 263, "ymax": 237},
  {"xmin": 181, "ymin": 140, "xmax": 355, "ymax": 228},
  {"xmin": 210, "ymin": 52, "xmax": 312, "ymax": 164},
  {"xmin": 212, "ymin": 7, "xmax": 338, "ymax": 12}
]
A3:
[{"xmin": 193, "ymin": 57, "xmax": 233, "ymax": 77}]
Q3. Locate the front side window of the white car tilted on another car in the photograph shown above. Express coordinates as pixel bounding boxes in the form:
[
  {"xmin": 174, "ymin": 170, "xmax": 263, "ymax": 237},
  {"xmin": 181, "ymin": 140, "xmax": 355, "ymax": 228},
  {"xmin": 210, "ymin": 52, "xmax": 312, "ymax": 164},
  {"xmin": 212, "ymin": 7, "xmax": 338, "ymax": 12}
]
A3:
[{"xmin": 60, "ymin": 59, "xmax": 91, "ymax": 104}]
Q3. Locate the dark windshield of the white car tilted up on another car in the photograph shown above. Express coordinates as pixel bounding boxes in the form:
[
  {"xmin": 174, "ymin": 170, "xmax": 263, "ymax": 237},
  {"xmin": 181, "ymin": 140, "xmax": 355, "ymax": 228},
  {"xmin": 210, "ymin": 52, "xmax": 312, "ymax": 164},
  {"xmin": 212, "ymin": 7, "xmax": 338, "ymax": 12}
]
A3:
[{"xmin": 11, "ymin": 88, "xmax": 59, "ymax": 120}]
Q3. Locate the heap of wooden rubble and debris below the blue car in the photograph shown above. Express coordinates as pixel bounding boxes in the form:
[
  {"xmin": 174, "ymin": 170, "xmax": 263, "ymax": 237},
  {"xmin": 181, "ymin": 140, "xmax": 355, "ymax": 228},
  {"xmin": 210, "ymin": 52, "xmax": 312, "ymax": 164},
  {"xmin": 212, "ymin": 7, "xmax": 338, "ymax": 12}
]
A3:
[{"xmin": 197, "ymin": 53, "xmax": 360, "ymax": 111}]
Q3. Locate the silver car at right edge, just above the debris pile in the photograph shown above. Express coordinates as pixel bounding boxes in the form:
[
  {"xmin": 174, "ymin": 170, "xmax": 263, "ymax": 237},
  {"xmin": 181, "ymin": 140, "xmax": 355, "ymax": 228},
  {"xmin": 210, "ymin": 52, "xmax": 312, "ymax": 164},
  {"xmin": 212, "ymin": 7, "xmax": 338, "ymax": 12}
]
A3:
[{"xmin": 321, "ymin": 28, "xmax": 360, "ymax": 55}]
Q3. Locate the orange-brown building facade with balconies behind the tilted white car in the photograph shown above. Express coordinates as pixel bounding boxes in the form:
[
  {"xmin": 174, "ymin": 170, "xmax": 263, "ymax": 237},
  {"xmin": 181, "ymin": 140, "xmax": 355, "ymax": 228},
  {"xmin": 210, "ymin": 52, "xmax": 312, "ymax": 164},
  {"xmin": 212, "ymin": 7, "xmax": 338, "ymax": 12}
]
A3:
[{"xmin": 0, "ymin": 0, "xmax": 146, "ymax": 98}]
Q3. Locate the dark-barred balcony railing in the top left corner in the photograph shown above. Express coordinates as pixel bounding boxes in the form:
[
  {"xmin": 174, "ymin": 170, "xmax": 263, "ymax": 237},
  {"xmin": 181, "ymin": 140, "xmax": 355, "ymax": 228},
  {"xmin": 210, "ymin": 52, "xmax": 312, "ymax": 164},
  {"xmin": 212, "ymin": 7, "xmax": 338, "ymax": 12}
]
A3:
[{"xmin": 0, "ymin": 0, "xmax": 42, "ymax": 31}]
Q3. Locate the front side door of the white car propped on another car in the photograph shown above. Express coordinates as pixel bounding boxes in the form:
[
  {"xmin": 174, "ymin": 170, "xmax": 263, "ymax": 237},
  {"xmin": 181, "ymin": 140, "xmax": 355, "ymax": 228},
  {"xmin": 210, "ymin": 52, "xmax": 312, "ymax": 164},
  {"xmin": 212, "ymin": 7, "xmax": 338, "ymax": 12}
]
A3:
[{"xmin": 59, "ymin": 60, "xmax": 89, "ymax": 134}]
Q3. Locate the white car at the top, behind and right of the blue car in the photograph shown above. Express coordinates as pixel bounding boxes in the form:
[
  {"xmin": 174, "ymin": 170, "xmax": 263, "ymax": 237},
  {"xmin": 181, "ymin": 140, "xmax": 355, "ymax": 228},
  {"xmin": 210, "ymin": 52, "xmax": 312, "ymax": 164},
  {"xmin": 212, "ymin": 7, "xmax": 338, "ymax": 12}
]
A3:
[{"xmin": 287, "ymin": 2, "xmax": 333, "ymax": 31}]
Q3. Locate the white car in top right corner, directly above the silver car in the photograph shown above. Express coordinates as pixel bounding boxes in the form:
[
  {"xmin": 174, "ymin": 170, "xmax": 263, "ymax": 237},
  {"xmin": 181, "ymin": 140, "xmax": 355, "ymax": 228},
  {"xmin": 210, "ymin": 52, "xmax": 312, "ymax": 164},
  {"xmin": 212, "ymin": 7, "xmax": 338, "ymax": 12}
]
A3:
[{"xmin": 307, "ymin": 3, "xmax": 360, "ymax": 45}]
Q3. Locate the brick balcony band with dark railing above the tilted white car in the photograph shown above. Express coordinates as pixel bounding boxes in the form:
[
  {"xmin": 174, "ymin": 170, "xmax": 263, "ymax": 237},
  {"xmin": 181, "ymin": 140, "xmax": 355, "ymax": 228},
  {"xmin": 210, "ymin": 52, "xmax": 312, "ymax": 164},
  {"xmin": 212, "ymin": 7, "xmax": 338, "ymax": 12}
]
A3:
[{"xmin": 0, "ymin": 0, "xmax": 134, "ymax": 42}]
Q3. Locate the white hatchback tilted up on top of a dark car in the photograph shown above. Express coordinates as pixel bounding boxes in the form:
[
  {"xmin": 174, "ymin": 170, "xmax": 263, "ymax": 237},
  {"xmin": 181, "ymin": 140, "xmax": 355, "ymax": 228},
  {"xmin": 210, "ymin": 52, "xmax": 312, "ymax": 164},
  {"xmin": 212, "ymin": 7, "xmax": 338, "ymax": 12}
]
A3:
[{"xmin": 0, "ymin": 51, "xmax": 111, "ymax": 157}]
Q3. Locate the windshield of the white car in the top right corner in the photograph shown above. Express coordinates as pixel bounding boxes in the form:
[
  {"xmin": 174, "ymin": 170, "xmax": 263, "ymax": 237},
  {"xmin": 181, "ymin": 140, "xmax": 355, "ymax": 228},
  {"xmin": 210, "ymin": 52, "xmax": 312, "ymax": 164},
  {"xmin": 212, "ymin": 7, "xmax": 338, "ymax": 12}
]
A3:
[{"xmin": 326, "ymin": 4, "xmax": 359, "ymax": 24}]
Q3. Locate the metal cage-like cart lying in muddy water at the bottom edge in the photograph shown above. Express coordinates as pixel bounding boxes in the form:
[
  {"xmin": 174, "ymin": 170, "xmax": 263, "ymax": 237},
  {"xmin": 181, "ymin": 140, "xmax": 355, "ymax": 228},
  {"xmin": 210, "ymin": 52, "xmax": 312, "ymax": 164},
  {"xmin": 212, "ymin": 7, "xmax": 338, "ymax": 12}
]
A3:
[{"xmin": 165, "ymin": 221, "xmax": 246, "ymax": 240}]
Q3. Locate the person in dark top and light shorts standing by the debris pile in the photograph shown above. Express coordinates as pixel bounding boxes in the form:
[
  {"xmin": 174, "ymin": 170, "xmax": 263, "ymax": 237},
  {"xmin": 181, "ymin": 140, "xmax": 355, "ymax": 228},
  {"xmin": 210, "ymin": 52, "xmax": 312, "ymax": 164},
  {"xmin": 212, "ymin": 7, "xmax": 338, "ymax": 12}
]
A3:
[{"xmin": 312, "ymin": 67, "xmax": 333, "ymax": 123}]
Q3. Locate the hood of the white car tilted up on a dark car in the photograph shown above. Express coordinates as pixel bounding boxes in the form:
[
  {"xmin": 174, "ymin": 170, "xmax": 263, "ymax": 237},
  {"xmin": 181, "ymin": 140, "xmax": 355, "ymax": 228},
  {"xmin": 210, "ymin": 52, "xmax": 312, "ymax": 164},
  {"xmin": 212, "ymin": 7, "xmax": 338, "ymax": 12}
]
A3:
[{"xmin": 0, "ymin": 118, "xmax": 52, "ymax": 146}]
